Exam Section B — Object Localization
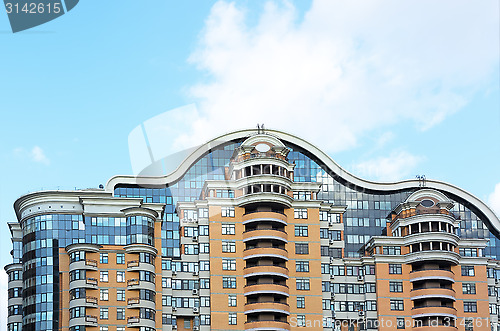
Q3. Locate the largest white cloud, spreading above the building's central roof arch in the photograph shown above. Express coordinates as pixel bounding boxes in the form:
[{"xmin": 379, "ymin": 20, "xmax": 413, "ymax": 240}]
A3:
[{"xmin": 174, "ymin": 0, "xmax": 498, "ymax": 153}]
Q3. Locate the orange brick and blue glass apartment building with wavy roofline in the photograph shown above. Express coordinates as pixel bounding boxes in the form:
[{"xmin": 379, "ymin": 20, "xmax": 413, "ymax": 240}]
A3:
[{"xmin": 5, "ymin": 130, "xmax": 500, "ymax": 331}]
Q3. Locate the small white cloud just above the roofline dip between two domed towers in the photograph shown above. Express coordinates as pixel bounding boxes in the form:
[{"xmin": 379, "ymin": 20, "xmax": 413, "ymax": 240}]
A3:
[{"xmin": 352, "ymin": 151, "xmax": 422, "ymax": 182}]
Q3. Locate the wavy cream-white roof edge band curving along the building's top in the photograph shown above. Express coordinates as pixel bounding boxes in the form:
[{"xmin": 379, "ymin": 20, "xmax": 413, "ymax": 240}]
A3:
[{"xmin": 106, "ymin": 129, "xmax": 500, "ymax": 233}]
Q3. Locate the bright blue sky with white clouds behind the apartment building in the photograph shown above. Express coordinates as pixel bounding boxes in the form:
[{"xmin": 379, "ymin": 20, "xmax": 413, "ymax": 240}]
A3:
[{"xmin": 0, "ymin": 0, "xmax": 500, "ymax": 328}]
